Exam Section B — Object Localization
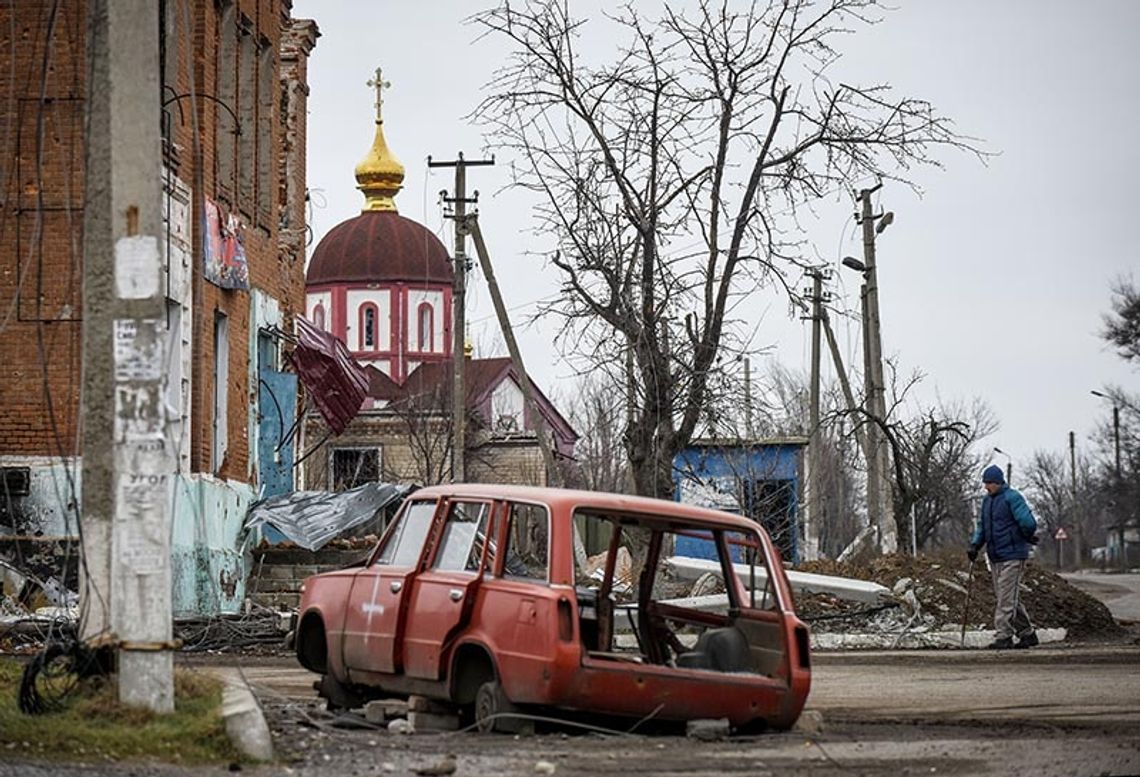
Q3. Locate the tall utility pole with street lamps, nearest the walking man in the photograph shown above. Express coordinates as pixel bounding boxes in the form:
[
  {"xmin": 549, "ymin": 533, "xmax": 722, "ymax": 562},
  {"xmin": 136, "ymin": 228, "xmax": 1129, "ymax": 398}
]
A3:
[{"xmin": 858, "ymin": 183, "xmax": 898, "ymax": 553}]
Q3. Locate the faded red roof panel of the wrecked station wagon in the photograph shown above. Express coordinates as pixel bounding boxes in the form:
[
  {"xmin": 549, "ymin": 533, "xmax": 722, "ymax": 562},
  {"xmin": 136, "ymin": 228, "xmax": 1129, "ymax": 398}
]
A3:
[{"xmin": 408, "ymin": 483, "xmax": 760, "ymax": 530}]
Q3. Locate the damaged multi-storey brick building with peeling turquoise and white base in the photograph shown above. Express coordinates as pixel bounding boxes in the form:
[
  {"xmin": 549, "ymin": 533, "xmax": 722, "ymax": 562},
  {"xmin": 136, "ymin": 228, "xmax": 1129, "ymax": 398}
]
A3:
[{"xmin": 0, "ymin": 0, "xmax": 319, "ymax": 613}]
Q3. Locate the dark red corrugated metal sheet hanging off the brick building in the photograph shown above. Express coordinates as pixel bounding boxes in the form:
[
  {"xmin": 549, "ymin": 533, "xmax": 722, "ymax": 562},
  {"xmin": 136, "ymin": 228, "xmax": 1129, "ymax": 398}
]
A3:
[{"xmin": 291, "ymin": 316, "xmax": 368, "ymax": 434}]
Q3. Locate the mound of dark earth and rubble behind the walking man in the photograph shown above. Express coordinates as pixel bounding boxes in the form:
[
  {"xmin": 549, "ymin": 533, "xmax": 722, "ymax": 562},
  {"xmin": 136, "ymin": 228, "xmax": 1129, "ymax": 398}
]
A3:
[{"xmin": 796, "ymin": 551, "xmax": 1123, "ymax": 639}]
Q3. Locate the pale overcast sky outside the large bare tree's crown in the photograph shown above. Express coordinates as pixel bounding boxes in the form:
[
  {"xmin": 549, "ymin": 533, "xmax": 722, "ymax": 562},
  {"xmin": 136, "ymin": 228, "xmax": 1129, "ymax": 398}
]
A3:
[{"xmin": 294, "ymin": 0, "xmax": 1140, "ymax": 466}]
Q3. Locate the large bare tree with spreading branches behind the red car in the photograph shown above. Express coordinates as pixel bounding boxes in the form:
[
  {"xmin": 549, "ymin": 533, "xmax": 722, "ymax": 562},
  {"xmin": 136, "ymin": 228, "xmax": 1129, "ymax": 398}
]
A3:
[{"xmin": 474, "ymin": 0, "xmax": 977, "ymax": 496}]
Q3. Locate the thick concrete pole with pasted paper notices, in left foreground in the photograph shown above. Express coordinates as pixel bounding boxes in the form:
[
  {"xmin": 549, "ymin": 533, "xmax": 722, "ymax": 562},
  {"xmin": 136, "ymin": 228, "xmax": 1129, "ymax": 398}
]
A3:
[{"xmin": 80, "ymin": 0, "xmax": 176, "ymax": 712}]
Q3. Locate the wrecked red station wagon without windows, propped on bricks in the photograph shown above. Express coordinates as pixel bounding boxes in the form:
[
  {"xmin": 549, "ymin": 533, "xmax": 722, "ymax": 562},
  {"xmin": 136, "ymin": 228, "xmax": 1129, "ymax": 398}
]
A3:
[{"xmin": 298, "ymin": 484, "xmax": 811, "ymax": 728}]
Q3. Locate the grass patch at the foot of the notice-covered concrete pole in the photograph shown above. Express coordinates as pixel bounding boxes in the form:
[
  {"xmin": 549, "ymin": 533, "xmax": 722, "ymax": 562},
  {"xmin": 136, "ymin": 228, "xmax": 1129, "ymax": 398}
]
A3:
[{"xmin": 0, "ymin": 657, "xmax": 241, "ymax": 763}]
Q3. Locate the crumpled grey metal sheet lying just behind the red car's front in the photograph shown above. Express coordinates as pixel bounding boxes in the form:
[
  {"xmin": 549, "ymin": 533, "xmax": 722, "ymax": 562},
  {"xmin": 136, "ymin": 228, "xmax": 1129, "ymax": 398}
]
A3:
[{"xmin": 245, "ymin": 483, "xmax": 415, "ymax": 550}]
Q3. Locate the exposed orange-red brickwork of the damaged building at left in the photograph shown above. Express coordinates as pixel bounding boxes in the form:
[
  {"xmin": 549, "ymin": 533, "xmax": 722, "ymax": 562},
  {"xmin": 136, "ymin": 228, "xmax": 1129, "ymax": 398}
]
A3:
[{"xmin": 0, "ymin": 0, "xmax": 318, "ymax": 489}]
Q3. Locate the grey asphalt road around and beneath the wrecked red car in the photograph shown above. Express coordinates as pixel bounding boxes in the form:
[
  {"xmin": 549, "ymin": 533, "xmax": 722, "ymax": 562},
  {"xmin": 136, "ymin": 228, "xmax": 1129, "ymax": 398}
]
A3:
[{"xmin": 0, "ymin": 644, "xmax": 1140, "ymax": 777}]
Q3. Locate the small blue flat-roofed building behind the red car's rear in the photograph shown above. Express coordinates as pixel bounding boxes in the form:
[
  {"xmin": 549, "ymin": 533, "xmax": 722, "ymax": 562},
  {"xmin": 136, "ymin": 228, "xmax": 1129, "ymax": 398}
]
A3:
[{"xmin": 673, "ymin": 437, "xmax": 807, "ymax": 563}]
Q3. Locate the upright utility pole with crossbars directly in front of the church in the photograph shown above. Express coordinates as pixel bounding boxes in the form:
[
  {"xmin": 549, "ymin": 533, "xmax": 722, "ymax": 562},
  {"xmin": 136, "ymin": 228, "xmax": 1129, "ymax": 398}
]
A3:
[{"xmin": 428, "ymin": 152, "xmax": 495, "ymax": 483}]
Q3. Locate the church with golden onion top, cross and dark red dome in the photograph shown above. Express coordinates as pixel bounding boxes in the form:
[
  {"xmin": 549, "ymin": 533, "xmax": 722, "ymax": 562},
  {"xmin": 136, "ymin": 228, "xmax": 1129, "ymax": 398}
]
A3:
[{"xmin": 300, "ymin": 73, "xmax": 578, "ymax": 491}]
